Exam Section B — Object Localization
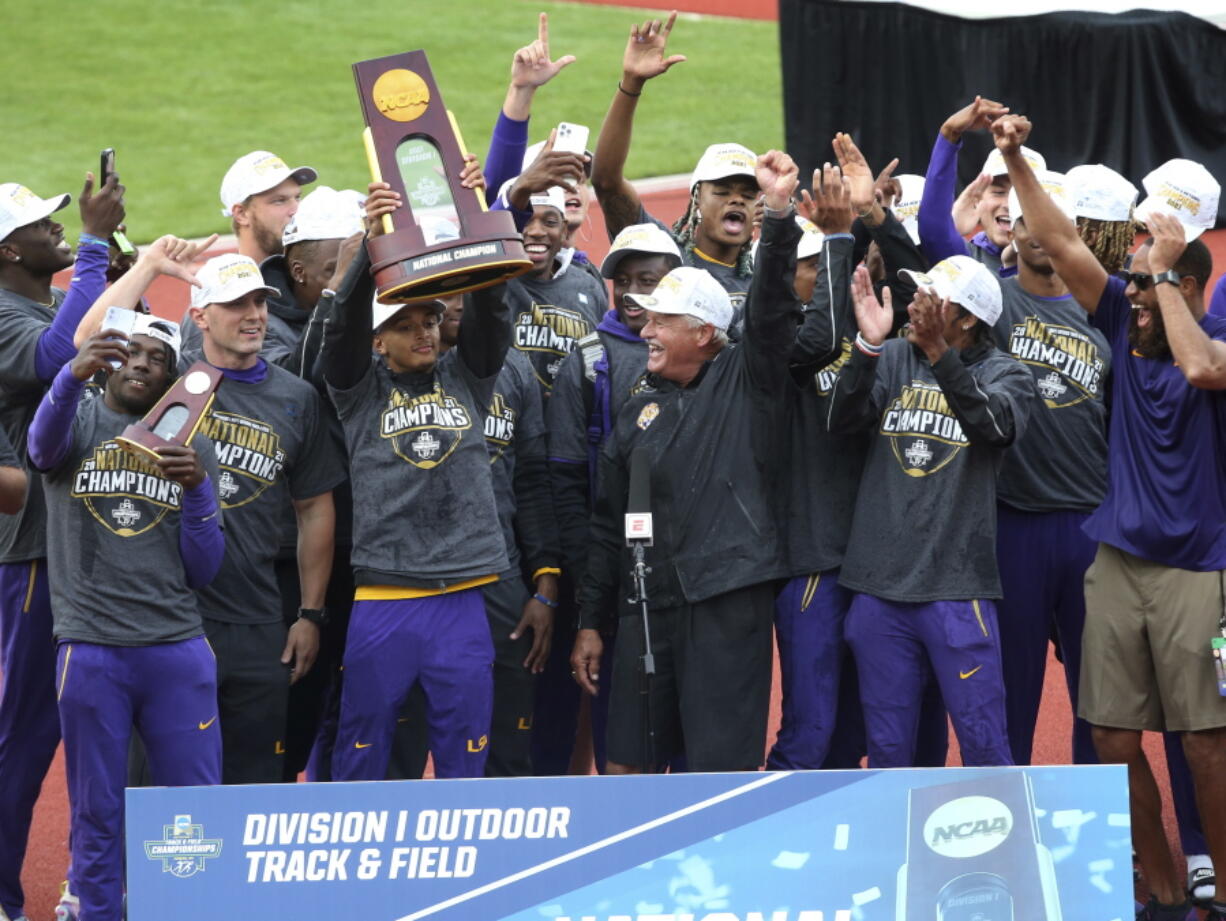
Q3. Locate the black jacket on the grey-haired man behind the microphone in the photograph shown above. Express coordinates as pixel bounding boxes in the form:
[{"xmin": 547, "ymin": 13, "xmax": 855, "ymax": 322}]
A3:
[{"xmin": 579, "ymin": 216, "xmax": 801, "ymax": 628}]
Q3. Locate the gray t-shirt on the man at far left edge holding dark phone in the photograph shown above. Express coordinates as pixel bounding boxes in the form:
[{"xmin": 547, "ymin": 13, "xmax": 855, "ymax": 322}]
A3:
[{"xmin": 0, "ymin": 288, "xmax": 64, "ymax": 563}]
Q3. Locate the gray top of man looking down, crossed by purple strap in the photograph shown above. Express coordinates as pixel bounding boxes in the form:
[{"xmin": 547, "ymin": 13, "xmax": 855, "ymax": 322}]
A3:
[{"xmin": 546, "ymin": 331, "xmax": 647, "ymax": 464}]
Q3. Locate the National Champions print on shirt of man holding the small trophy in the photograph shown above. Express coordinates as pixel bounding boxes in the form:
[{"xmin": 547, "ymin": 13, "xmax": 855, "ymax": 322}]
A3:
[{"xmin": 69, "ymin": 441, "xmax": 183, "ymax": 537}]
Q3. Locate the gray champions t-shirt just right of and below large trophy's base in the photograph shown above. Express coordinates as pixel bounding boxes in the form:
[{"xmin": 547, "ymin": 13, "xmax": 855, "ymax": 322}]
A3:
[{"xmin": 505, "ymin": 266, "xmax": 608, "ymax": 392}]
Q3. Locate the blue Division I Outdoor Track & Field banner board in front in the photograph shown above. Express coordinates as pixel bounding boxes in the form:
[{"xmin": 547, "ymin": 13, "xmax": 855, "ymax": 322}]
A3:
[{"xmin": 126, "ymin": 765, "xmax": 1133, "ymax": 921}]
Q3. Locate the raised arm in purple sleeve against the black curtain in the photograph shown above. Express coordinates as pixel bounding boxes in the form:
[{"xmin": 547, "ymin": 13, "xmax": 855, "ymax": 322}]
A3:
[{"xmin": 917, "ymin": 96, "xmax": 1009, "ymax": 264}]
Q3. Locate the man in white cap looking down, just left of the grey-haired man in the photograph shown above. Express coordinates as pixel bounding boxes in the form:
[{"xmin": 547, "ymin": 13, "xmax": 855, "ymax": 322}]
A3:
[{"xmin": 544, "ymin": 223, "xmax": 682, "ymax": 774}]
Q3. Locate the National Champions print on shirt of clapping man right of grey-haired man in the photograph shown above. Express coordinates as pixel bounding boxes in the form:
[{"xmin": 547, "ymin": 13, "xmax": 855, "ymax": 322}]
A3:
[{"xmin": 880, "ymin": 380, "xmax": 969, "ymax": 477}]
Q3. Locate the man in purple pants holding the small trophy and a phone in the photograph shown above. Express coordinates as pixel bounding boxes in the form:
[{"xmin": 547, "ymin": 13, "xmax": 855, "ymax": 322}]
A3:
[{"xmin": 29, "ymin": 314, "xmax": 226, "ymax": 919}]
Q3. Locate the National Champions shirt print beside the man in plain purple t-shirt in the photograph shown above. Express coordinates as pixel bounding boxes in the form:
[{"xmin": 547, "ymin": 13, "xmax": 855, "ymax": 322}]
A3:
[{"xmin": 1009, "ymin": 316, "xmax": 1106, "ymax": 410}]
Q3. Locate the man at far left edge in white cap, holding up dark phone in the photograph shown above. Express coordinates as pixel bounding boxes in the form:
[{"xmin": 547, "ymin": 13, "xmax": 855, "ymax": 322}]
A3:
[{"xmin": 0, "ymin": 175, "xmax": 124, "ymax": 920}]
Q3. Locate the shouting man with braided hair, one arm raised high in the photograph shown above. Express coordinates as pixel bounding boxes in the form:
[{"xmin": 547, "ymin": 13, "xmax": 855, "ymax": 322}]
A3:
[{"xmin": 592, "ymin": 13, "xmax": 759, "ymax": 340}]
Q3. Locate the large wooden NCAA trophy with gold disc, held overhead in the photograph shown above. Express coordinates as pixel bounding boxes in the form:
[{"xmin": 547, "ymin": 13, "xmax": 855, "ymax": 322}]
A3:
[{"xmin": 353, "ymin": 52, "xmax": 532, "ymax": 303}]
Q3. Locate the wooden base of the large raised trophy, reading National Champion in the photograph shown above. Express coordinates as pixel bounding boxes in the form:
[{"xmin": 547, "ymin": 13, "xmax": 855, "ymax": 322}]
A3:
[{"xmin": 368, "ymin": 211, "xmax": 532, "ymax": 304}]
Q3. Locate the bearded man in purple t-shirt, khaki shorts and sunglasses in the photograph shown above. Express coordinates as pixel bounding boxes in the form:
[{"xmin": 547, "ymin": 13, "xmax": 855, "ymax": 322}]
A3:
[{"xmin": 992, "ymin": 115, "xmax": 1226, "ymax": 921}]
